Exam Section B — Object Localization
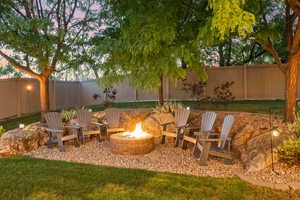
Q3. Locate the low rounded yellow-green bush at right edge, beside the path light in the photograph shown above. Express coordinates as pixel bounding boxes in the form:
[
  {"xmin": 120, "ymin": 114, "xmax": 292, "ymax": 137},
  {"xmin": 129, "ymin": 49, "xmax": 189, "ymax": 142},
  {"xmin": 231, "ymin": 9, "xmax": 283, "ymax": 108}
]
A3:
[{"xmin": 278, "ymin": 139, "xmax": 300, "ymax": 165}]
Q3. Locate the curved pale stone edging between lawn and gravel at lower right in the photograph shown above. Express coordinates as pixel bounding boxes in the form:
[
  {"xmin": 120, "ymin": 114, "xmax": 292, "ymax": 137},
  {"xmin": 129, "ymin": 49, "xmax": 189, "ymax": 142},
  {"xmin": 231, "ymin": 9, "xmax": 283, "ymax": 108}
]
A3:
[{"xmin": 235, "ymin": 172, "xmax": 300, "ymax": 191}]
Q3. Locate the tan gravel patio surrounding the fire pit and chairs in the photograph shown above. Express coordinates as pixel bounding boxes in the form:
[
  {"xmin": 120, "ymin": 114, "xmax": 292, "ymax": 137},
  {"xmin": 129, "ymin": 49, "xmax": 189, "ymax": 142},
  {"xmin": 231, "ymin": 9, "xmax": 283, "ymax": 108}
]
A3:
[{"xmin": 27, "ymin": 140, "xmax": 241, "ymax": 178}]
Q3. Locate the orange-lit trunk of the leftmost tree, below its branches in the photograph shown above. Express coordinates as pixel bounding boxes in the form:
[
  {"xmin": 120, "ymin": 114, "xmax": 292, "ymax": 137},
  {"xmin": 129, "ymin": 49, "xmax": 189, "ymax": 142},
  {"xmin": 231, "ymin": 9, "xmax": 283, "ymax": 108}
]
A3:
[{"xmin": 39, "ymin": 76, "xmax": 49, "ymax": 113}]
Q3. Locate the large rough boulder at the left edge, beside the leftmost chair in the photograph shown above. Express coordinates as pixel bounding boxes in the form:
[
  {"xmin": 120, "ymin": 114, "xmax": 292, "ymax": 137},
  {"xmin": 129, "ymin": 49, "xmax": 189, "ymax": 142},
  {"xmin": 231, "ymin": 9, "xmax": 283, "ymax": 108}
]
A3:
[{"xmin": 0, "ymin": 128, "xmax": 49, "ymax": 157}]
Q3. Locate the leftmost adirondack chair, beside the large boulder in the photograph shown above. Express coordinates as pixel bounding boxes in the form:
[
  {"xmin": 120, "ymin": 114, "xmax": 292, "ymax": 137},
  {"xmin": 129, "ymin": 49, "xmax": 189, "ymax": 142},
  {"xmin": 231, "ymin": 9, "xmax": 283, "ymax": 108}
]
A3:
[{"xmin": 44, "ymin": 112, "xmax": 79, "ymax": 152}]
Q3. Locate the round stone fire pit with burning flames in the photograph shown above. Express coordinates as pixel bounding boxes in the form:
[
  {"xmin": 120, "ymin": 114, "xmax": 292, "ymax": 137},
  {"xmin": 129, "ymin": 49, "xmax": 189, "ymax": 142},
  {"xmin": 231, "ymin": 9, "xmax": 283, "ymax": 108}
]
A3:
[{"xmin": 110, "ymin": 124, "xmax": 154, "ymax": 155}]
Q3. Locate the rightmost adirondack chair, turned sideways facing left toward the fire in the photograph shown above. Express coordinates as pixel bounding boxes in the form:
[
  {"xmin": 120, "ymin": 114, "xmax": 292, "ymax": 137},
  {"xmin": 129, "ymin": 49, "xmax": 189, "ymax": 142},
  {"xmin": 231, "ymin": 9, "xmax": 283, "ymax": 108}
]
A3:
[{"xmin": 195, "ymin": 115, "xmax": 234, "ymax": 165}]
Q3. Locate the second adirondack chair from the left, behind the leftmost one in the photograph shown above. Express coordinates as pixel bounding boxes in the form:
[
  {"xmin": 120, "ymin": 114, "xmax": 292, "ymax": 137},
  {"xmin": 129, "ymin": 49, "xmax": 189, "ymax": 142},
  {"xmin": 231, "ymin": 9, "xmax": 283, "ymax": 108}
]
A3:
[{"xmin": 77, "ymin": 109, "xmax": 105, "ymax": 144}]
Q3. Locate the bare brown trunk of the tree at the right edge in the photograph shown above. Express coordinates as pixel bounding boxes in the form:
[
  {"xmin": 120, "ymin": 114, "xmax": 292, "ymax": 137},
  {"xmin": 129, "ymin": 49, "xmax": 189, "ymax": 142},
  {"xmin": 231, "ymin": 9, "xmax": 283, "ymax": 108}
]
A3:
[{"xmin": 285, "ymin": 55, "xmax": 299, "ymax": 122}]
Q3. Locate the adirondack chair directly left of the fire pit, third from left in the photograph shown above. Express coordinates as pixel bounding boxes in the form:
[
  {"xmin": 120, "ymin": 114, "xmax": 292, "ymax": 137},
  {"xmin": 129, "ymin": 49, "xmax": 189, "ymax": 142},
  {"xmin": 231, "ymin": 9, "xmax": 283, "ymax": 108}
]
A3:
[{"xmin": 103, "ymin": 109, "xmax": 125, "ymax": 137}]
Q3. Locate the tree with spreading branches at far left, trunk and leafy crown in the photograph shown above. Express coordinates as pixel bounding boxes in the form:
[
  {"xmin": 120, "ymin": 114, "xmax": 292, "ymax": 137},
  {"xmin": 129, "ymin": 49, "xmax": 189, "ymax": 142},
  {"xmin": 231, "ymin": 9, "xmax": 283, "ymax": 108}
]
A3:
[{"xmin": 0, "ymin": 0, "xmax": 99, "ymax": 112}]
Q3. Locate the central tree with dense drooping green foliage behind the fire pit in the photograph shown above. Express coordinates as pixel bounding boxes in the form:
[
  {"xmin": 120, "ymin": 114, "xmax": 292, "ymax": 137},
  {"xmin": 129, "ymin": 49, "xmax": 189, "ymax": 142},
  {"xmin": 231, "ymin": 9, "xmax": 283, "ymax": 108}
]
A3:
[{"xmin": 94, "ymin": 0, "xmax": 209, "ymax": 104}]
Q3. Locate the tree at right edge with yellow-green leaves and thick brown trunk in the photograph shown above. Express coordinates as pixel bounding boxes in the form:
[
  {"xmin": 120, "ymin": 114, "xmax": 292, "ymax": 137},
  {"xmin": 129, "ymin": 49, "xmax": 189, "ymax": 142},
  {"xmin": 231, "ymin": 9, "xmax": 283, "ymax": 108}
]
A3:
[{"xmin": 211, "ymin": 0, "xmax": 300, "ymax": 122}]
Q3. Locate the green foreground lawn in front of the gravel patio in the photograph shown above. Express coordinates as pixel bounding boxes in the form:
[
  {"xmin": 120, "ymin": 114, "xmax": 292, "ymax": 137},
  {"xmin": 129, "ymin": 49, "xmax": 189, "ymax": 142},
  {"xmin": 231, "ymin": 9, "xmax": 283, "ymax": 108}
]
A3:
[{"xmin": 0, "ymin": 156, "xmax": 300, "ymax": 200}]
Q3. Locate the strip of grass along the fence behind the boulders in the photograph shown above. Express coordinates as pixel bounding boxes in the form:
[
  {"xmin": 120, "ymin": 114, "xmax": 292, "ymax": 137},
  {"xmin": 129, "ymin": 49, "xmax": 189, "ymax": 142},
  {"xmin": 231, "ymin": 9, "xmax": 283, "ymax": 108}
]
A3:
[{"xmin": 0, "ymin": 100, "xmax": 284, "ymax": 130}]
